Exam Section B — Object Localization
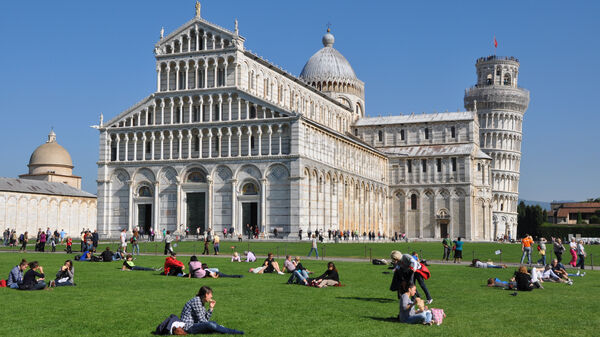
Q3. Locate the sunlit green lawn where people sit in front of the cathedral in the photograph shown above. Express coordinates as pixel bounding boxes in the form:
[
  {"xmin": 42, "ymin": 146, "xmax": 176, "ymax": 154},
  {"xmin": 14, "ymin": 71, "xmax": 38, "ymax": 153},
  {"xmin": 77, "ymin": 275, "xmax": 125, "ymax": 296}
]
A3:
[{"xmin": 0, "ymin": 245, "xmax": 600, "ymax": 336}]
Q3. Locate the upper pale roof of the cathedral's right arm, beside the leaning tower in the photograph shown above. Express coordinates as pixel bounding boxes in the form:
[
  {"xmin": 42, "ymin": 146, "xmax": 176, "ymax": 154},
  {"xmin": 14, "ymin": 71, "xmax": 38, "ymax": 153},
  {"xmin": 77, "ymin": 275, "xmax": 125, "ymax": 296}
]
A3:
[{"xmin": 355, "ymin": 111, "xmax": 475, "ymax": 126}]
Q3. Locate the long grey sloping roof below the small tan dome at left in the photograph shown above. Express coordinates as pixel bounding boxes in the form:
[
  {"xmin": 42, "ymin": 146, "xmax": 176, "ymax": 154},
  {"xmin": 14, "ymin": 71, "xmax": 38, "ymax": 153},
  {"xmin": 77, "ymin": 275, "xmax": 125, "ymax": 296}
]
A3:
[{"xmin": 0, "ymin": 177, "xmax": 97, "ymax": 199}]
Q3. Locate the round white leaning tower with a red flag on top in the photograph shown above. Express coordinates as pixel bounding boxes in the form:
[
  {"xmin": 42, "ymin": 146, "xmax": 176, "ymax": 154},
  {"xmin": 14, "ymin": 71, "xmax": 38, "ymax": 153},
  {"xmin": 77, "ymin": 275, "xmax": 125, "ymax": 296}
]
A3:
[{"xmin": 465, "ymin": 55, "xmax": 529, "ymax": 238}]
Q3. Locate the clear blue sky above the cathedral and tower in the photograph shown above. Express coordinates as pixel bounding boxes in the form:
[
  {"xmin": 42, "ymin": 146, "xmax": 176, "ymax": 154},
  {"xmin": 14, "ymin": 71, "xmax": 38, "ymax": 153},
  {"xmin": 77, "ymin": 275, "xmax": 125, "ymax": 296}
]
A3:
[{"xmin": 0, "ymin": 0, "xmax": 600, "ymax": 201}]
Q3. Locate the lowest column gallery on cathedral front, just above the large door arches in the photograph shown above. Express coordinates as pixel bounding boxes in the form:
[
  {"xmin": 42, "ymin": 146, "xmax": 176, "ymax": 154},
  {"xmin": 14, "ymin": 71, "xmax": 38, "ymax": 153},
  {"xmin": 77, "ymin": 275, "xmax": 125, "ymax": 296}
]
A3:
[{"xmin": 105, "ymin": 123, "xmax": 290, "ymax": 162}]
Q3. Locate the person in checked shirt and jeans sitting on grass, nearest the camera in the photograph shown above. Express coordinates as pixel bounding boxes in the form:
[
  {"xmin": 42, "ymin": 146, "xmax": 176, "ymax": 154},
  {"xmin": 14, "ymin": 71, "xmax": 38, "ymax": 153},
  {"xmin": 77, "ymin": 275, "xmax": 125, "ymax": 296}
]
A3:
[{"xmin": 178, "ymin": 286, "xmax": 244, "ymax": 335}]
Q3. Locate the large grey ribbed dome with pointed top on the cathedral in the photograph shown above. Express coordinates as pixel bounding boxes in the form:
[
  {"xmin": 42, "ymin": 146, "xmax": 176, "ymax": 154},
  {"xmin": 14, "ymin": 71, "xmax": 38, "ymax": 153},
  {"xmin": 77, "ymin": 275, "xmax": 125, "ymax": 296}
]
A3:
[{"xmin": 300, "ymin": 31, "xmax": 358, "ymax": 83}]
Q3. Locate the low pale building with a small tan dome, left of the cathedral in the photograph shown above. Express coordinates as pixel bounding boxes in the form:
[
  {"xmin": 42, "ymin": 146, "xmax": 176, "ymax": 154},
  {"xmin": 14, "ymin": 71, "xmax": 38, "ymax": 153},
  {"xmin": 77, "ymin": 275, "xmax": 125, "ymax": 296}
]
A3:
[{"xmin": 0, "ymin": 131, "xmax": 97, "ymax": 238}]
